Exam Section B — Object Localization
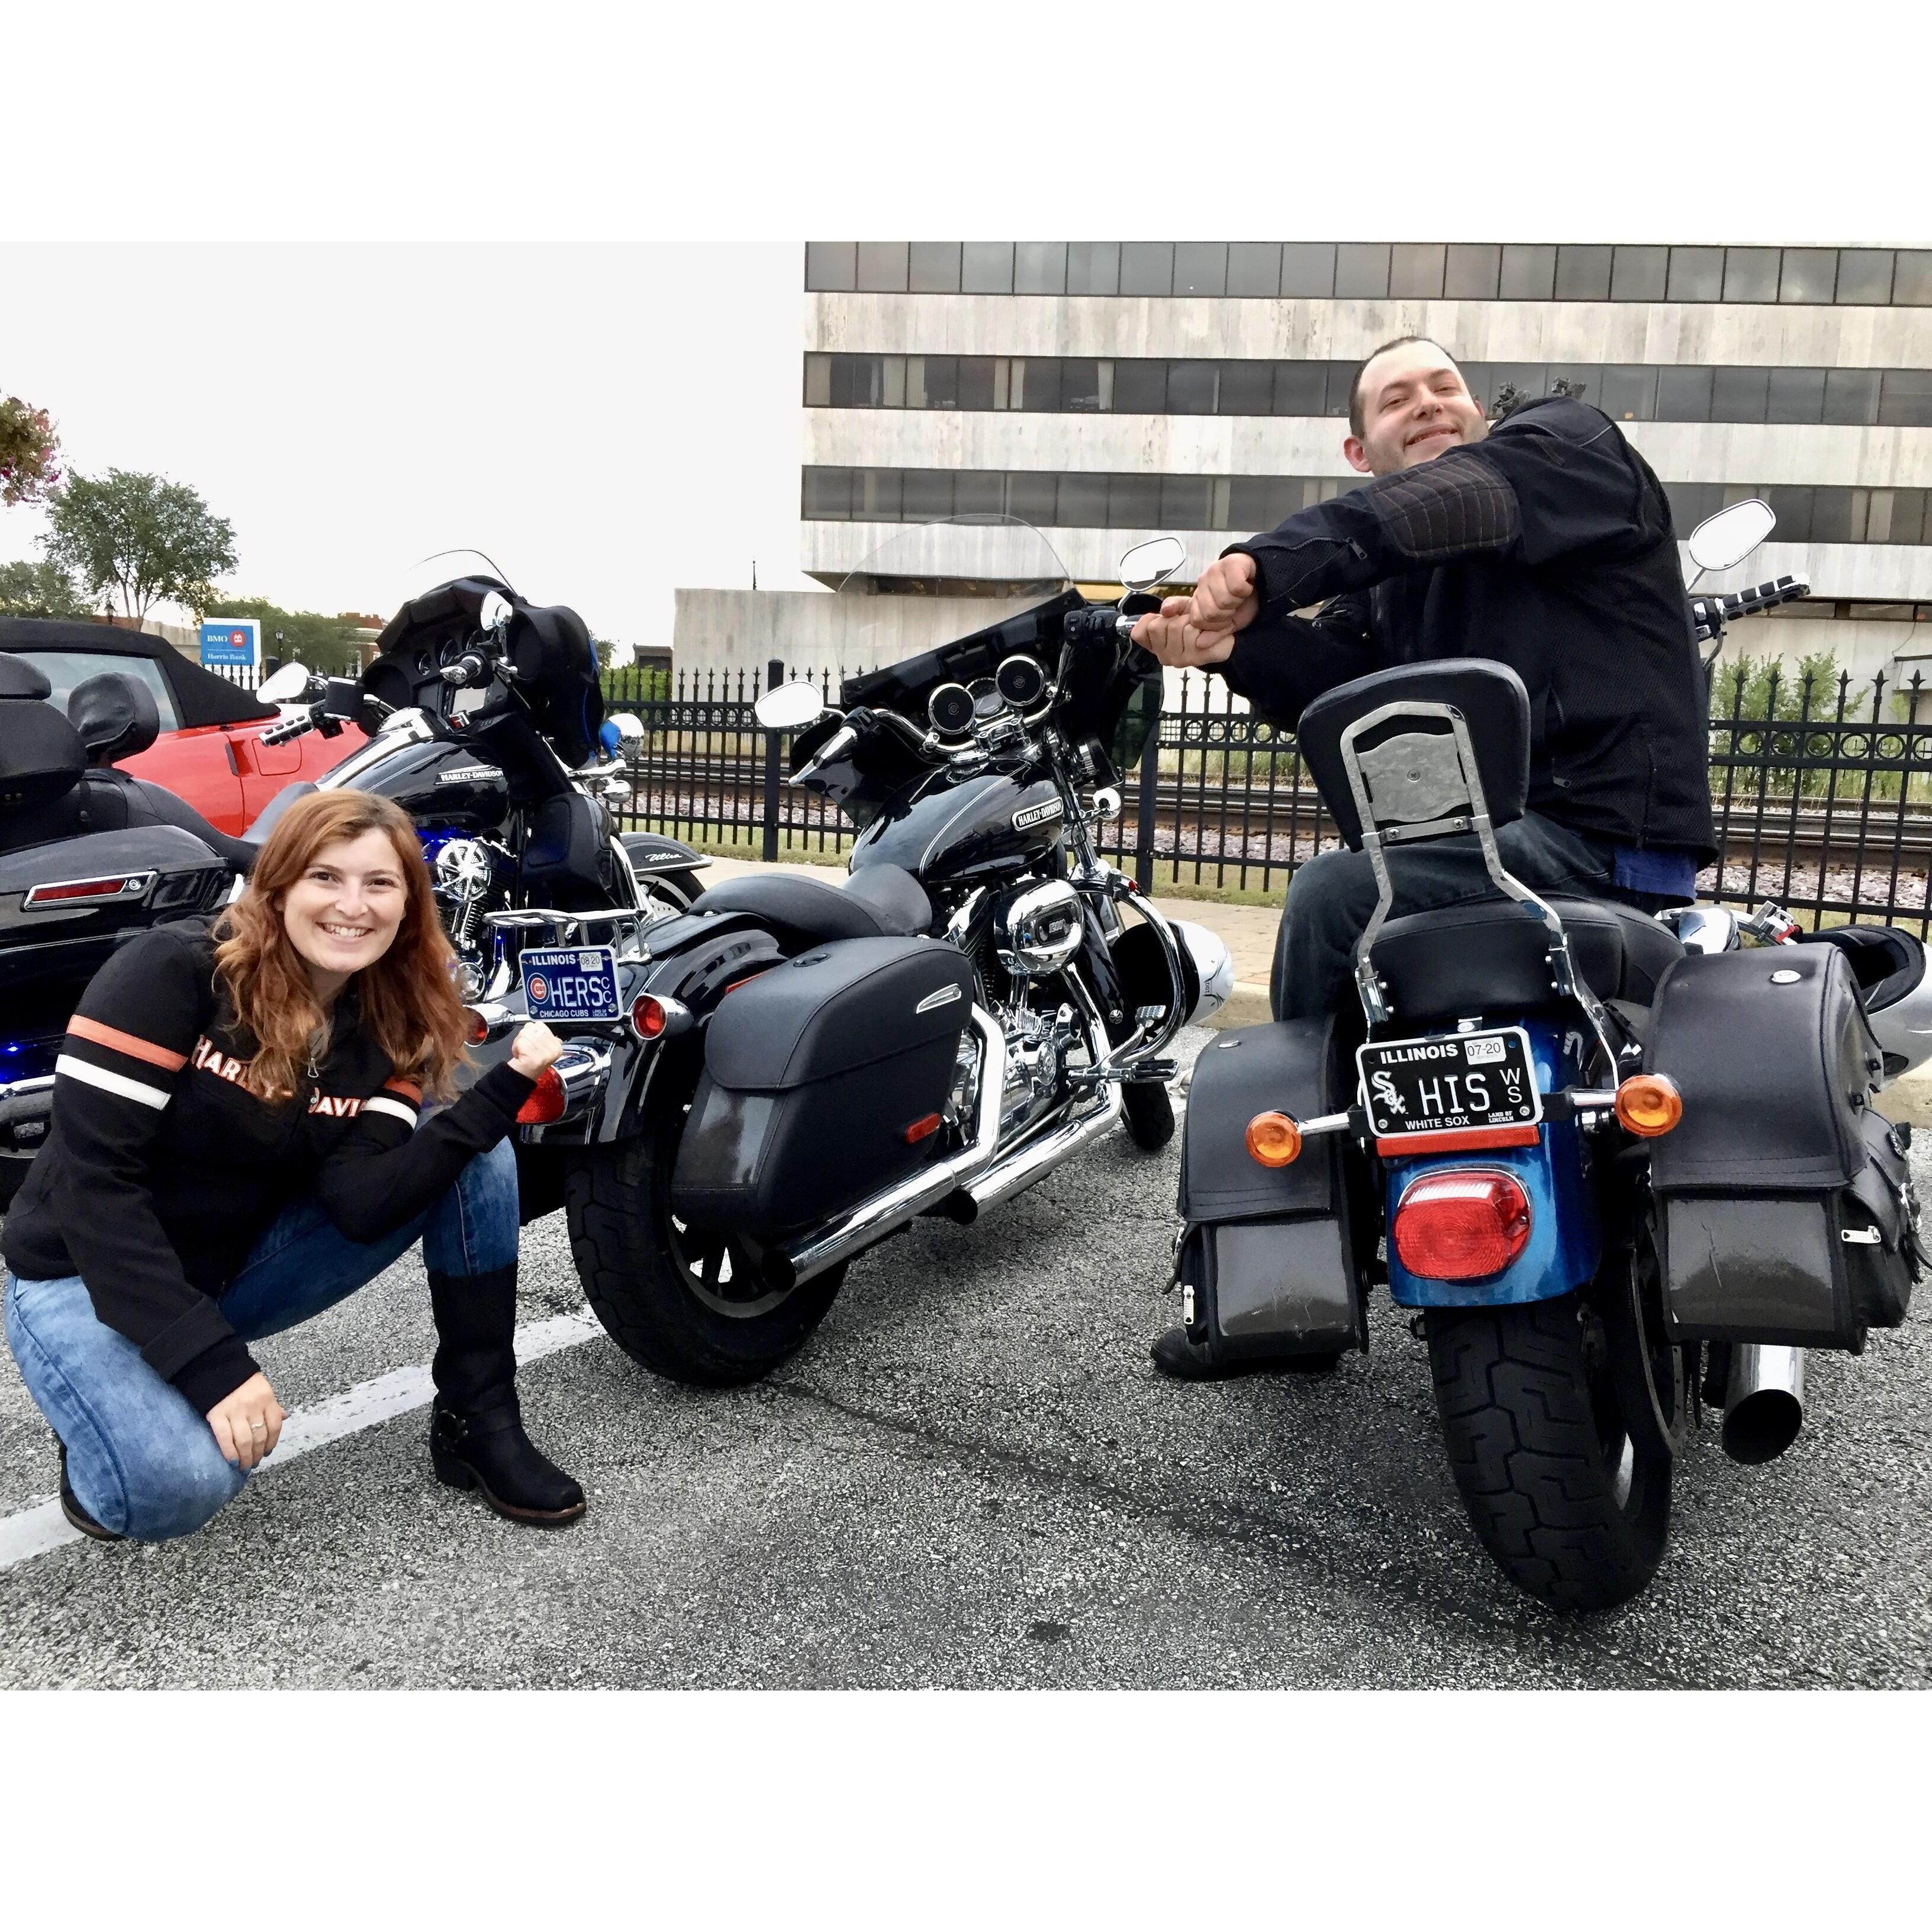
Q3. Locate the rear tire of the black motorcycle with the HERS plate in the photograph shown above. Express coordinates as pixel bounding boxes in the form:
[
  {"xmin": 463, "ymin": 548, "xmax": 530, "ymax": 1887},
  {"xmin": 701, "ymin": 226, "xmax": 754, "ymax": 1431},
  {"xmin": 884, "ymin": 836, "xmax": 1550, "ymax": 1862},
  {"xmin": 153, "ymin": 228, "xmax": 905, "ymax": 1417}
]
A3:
[{"xmin": 564, "ymin": 1107, "xmax": 846, "ymax": 1389}]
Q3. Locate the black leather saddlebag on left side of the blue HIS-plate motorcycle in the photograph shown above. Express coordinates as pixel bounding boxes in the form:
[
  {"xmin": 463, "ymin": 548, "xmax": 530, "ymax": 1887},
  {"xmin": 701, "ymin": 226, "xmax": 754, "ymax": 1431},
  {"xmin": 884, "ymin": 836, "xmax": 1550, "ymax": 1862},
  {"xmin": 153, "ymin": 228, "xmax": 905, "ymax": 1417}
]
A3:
[{"xmin": 1178, "ymin": 1018, "xmax": 1374, "ymax": 1362}]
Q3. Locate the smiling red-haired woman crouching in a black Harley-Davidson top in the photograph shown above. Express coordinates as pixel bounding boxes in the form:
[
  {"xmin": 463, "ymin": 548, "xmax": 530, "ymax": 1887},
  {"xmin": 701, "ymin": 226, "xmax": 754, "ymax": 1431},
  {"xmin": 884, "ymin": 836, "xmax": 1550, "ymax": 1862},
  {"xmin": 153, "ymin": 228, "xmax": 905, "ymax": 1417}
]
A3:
[{"xmin": 4, "ymin": 790, "xmax": 584, "ymax": 1542}]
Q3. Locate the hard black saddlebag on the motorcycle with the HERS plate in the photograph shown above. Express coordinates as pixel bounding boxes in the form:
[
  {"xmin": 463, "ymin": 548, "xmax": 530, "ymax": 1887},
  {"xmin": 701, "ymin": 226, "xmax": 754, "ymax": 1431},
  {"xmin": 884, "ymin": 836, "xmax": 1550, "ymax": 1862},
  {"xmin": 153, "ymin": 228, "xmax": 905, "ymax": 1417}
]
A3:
[{"xmin": 671, "ymin": 939, "xmax": 972, "ymax": 1240}]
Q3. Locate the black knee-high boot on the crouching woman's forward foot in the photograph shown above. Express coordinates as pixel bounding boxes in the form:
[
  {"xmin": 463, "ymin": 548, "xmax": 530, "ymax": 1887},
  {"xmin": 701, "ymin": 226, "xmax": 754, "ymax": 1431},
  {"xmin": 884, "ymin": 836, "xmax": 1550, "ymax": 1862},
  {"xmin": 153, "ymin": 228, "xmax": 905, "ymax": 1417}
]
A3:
[{"xmin": 429, "ymin": 1264, "xmax": 584, "ymax": 1527}]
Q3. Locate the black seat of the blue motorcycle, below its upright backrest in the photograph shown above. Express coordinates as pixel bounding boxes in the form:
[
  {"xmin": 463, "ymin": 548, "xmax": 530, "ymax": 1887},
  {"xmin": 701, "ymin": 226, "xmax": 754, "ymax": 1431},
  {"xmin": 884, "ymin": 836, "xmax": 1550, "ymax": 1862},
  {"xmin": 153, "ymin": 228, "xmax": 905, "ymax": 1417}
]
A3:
[{"xmin": 1374, "ymin": 893, "xmax": 1683, "ymax": 1020}]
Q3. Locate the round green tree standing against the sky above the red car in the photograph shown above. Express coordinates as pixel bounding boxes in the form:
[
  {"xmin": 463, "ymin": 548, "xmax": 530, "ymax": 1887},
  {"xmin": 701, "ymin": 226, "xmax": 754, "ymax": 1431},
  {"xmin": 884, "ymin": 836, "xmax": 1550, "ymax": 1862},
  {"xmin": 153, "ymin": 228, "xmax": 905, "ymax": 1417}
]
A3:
[{"xmin": 43, "ymin": 469, "xmax": 236, "ymax": 618}]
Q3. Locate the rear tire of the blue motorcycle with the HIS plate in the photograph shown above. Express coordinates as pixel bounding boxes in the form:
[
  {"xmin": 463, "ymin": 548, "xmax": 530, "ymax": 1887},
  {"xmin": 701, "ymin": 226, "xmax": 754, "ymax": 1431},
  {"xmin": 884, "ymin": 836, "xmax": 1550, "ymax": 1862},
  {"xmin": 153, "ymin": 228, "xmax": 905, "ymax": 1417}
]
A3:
[{"xmin": 1426, "ymin": 1295, "xmax": 1671, "ymax": 1613}]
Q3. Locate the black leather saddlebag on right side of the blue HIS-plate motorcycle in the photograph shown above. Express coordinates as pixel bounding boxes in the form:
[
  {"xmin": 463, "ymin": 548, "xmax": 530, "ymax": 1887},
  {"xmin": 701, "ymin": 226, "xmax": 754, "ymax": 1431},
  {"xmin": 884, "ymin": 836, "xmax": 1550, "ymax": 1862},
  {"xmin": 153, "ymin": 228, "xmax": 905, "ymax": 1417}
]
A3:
[{"xmin": 1644, "ymin": 946, "xmax": 1920, "ymax": 1351}]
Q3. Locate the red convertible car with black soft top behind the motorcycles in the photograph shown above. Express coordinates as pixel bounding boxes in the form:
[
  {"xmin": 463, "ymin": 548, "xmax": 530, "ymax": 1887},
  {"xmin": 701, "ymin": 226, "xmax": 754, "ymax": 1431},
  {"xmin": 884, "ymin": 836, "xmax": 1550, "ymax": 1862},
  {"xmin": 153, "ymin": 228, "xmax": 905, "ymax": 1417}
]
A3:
[{"xmin": 0, "ymin": 616, "xmax": 367, "ymax": 835}]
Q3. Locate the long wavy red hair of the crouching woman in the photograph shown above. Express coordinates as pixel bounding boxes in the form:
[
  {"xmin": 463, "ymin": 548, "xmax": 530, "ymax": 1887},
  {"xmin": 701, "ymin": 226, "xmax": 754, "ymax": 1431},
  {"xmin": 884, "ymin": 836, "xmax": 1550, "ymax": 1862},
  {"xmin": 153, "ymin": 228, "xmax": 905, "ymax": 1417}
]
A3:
[{"xmin": 214, "ymin": 790, "xmax": 468, "ymax": 1101}]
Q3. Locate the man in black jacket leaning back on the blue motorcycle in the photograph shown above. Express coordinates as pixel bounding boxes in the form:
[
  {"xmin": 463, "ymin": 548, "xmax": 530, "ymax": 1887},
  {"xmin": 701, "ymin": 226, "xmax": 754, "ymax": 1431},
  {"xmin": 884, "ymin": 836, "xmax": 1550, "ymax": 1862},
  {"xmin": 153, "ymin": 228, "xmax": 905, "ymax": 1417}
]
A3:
[{"xmin": 1134, "ymin": 336, "xmax": 1715, "ymax": 1376}]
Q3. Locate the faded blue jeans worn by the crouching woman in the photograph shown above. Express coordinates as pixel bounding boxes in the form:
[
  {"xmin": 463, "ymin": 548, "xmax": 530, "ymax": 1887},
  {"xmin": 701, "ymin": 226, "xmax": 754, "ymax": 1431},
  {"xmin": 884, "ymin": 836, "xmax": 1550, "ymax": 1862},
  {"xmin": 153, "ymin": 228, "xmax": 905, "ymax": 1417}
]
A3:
[{"xmin": 6, "ymin": 1140, "xmax": 518, "ymax": 1544}]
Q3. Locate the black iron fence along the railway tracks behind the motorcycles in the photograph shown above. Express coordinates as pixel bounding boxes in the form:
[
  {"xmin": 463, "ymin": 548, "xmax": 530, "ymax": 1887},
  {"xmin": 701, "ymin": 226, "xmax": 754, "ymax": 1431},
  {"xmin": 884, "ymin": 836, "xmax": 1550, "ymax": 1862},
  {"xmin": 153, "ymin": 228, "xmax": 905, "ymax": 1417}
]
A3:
[{"xmin": 605, "ymin": 663, "xmax": 1932, "ymax": 937}]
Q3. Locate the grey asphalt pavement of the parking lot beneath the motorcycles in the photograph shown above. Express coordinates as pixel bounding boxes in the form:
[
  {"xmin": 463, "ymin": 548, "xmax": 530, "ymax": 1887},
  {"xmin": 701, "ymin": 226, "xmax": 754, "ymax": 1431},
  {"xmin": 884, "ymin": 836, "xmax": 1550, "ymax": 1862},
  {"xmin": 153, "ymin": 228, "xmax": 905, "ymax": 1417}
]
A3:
[{"xmin": 0, "ymin": 1032, "xmax": 1932, "ymax": 1686}]
